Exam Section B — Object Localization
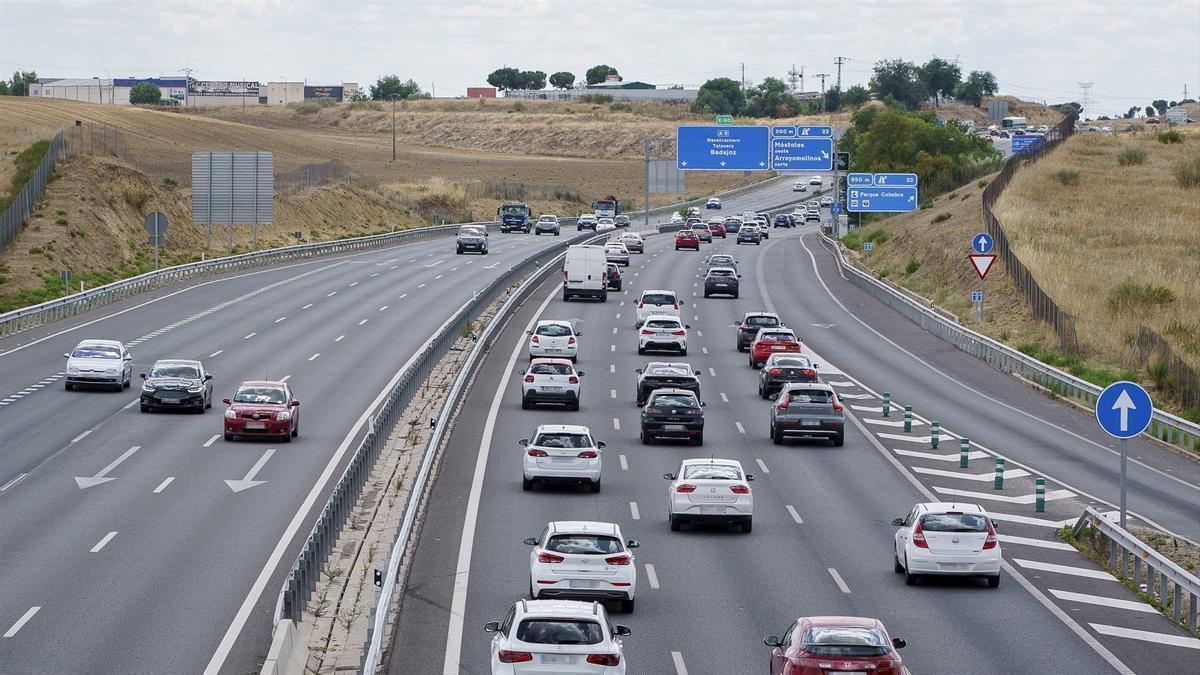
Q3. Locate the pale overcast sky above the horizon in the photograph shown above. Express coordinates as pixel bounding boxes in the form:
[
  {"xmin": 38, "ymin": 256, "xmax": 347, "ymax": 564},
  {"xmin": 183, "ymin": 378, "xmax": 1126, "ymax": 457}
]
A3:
[{"xmin": 0, "ymin": 0, "xmax": 1200, "ymax": 115}]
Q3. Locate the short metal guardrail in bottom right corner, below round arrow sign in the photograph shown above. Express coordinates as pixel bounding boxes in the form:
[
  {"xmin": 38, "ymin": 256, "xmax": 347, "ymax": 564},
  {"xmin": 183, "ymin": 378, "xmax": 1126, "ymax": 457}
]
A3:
[{"xmin": 1072, "ymin": 507, "xmax": 1200, "ymax": 633}]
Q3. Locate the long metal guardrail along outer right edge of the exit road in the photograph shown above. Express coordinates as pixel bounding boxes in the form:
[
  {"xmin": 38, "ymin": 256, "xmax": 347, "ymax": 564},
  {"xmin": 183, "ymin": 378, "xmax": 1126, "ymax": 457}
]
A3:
[{"xmin": 821, "ymin": 234, "xmax": 1200, "ymax": 450}]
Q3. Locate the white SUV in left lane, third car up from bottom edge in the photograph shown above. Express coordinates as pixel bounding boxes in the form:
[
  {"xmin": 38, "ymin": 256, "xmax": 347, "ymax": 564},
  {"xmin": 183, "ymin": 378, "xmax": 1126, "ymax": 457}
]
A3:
[{"xmin": 518, "ymin": 424, "xmax": 605, "ymax": 492}]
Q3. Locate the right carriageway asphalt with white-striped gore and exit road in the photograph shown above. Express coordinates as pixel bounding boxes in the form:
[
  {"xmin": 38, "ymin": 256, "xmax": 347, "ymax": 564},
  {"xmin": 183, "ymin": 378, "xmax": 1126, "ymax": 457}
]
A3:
[{"xmin": 388, "ymin": 219, "xmax": 1200, "ymax": 675}]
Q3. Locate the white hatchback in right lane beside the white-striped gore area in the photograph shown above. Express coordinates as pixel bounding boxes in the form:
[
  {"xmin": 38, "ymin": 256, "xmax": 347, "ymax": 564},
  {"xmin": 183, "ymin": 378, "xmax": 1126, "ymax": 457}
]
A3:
[{"xmin": 892, "ymin": 502, "xmax": 1001, "ymax": 589}]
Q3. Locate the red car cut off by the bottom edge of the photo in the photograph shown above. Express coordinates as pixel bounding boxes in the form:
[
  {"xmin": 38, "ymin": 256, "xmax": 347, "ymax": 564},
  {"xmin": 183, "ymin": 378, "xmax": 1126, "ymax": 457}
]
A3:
[{"xmin": 763, "ymin": 616, "xmax": 907, "ymax": 675}]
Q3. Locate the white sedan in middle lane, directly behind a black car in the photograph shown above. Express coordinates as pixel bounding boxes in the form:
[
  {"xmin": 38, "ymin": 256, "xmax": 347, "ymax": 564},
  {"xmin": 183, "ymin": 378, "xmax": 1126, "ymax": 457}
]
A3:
[{"xmin": 662, "ymin": 458, "xmax": 754, "ymax": 532}]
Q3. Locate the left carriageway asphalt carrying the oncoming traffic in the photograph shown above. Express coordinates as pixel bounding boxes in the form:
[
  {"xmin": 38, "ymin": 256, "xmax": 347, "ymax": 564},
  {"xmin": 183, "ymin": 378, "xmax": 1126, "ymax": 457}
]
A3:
[{"xmin": 0, "ymin": 176, "xmax": 806, "ymax": 674}]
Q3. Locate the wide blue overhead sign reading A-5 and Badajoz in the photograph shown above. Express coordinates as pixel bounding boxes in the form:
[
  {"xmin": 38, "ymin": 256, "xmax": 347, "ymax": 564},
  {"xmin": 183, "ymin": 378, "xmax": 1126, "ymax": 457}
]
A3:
[{"xmin": 676, "ymin": 126, "xmax": 770, "ymax": 171}]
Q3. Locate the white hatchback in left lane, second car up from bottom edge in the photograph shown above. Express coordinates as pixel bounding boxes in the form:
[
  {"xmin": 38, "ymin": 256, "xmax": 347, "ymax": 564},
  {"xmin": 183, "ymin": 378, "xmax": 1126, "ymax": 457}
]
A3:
[{"xmin": 524, "ymin": 520, "xmax": 641, "ymax": 614}]
